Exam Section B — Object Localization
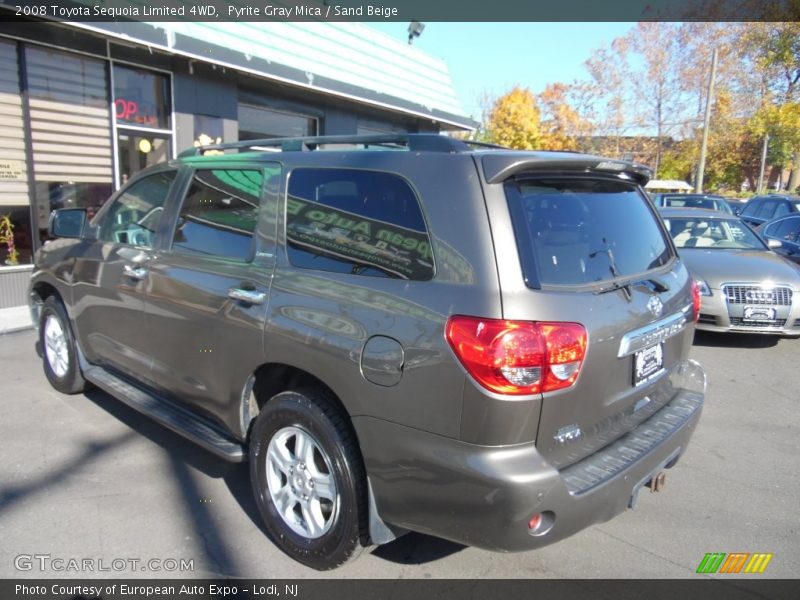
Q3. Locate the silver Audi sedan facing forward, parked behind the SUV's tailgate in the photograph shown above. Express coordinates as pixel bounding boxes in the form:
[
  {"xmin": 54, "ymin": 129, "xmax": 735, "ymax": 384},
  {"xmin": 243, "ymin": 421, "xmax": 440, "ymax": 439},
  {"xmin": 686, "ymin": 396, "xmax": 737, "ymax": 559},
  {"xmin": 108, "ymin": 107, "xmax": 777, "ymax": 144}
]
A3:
[{"xmin": 661, "ymin": 208, "xmax": 800, "ymax": 337}]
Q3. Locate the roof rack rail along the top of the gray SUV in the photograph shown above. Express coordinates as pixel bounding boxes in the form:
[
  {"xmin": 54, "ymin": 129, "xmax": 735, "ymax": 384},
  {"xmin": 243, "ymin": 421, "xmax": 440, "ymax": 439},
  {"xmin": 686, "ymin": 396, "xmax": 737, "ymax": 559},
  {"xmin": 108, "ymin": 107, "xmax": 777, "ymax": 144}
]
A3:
[{"xmin": 179, "ymin": 133, "xmax": 484, "ymax": 158}]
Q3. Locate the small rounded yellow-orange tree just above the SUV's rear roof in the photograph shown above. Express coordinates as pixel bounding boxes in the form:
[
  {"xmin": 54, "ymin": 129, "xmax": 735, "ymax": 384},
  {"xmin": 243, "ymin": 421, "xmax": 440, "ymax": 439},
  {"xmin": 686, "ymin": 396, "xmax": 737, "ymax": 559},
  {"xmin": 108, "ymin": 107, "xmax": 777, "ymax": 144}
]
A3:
[{"xmin": 486, "ymin": 86, "xmax": 542, "ymax": 150}]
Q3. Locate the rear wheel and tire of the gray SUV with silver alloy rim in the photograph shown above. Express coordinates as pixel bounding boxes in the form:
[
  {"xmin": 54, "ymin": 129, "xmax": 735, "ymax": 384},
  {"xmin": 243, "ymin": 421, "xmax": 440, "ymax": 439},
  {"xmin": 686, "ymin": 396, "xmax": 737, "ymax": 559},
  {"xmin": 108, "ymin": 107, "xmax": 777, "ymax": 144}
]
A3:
[{"xmin": 250, "ymin": 390, "xmax": 367, "ymax": 571}]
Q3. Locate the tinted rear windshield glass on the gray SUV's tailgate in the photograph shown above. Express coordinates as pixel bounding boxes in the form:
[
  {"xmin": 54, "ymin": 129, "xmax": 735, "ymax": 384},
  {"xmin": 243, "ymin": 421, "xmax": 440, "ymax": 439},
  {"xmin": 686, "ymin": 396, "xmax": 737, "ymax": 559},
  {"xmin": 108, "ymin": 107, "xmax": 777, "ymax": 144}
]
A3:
[{"xmin": 506, "ymin": 178, "xmax": 672, "ymax": 287}]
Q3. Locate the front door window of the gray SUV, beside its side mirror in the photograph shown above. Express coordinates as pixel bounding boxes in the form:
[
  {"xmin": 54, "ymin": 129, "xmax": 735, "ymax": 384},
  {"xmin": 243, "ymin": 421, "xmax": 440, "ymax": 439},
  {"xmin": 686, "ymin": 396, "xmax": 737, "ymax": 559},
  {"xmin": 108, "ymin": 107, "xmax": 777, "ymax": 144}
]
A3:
[{"xmin": 94, "ymin": 171, "xmax": 176, "ymax": 248}]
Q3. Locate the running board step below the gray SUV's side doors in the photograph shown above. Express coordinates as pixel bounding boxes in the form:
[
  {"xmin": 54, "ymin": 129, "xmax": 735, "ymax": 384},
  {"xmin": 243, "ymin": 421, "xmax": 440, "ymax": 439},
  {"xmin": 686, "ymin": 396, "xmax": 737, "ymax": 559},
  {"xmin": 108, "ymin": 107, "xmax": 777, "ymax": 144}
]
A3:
[{"xmin": 83, "ymin": 366, "xmax": 247, "ymax": 462}]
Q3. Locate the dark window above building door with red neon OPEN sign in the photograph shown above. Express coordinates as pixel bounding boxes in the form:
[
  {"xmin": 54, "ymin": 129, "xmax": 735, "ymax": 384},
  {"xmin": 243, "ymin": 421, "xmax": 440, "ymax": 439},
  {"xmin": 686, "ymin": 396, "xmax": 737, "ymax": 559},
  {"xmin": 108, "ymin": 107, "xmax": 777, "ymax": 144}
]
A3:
[{"xmin": 114, "ymin": 65, "xmax": 170, "ymax": 129}]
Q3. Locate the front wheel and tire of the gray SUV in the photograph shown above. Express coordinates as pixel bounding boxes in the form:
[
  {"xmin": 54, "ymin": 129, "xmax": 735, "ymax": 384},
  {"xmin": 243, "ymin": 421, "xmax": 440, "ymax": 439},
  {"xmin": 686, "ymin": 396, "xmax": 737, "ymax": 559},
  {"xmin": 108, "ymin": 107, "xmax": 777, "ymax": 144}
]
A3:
[{"xmin": 39, "ymin": 296, "xmax": 88, "ymax": 394}]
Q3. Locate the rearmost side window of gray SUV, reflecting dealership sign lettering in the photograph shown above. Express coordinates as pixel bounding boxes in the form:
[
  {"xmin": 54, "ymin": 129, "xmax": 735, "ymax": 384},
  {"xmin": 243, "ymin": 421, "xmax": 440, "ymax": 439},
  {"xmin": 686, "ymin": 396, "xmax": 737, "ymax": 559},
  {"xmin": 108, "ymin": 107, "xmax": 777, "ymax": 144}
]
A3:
[{"xmin": 286, "ymin": 168, "xmax": 434, "ymax": 280}]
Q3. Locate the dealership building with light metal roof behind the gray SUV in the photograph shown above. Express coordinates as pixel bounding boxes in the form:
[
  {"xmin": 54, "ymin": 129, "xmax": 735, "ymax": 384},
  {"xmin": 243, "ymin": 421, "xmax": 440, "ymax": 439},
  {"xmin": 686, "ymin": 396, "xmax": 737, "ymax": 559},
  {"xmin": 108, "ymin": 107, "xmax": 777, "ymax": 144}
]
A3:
[{"xmin": 0, "ymin": 21, "xmax": 475, "ymax": 309}]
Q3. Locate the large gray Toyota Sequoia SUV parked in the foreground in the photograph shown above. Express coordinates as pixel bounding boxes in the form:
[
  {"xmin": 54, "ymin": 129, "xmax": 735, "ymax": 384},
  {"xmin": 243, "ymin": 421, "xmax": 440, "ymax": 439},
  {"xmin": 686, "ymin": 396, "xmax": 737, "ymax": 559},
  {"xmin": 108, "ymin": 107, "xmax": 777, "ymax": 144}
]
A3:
[{"xmin": 30, "ymin": 135, "xmax": 705, "ymax": 569}]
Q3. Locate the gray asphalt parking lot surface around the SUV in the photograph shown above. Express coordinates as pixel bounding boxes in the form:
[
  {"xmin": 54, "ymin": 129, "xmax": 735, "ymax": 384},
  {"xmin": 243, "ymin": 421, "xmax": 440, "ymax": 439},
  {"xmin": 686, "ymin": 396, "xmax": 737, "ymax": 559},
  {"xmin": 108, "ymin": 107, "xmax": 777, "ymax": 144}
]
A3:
[{"xmin": 0, "ymin": 331, "xmax": 800, "ymax": 579}]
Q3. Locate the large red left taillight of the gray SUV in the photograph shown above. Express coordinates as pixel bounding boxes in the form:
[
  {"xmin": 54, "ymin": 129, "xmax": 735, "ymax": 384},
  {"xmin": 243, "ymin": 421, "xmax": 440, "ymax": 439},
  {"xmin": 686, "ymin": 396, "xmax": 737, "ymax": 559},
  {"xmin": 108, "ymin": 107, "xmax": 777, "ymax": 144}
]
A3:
[{"xmin": 445, "ymin": 315, "xmax": 586, "ymax": 396}]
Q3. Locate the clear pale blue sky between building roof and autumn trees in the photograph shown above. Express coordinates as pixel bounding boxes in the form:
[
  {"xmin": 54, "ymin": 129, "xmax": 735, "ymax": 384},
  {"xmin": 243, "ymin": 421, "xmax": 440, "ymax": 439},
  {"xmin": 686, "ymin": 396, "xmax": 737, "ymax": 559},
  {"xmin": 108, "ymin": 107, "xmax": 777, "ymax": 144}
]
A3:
[{"xmin": 370, "ymin": 22, "xmax": 636, "ymax": 120}]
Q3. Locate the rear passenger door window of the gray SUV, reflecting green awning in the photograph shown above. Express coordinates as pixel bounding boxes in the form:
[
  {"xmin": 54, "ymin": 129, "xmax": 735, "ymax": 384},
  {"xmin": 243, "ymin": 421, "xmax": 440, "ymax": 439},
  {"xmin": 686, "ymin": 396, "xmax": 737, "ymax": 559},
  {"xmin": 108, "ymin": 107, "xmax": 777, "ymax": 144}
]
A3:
[{"xmin": 172, "ymin": 169, "xmax": 264, "ymax": 262}]
